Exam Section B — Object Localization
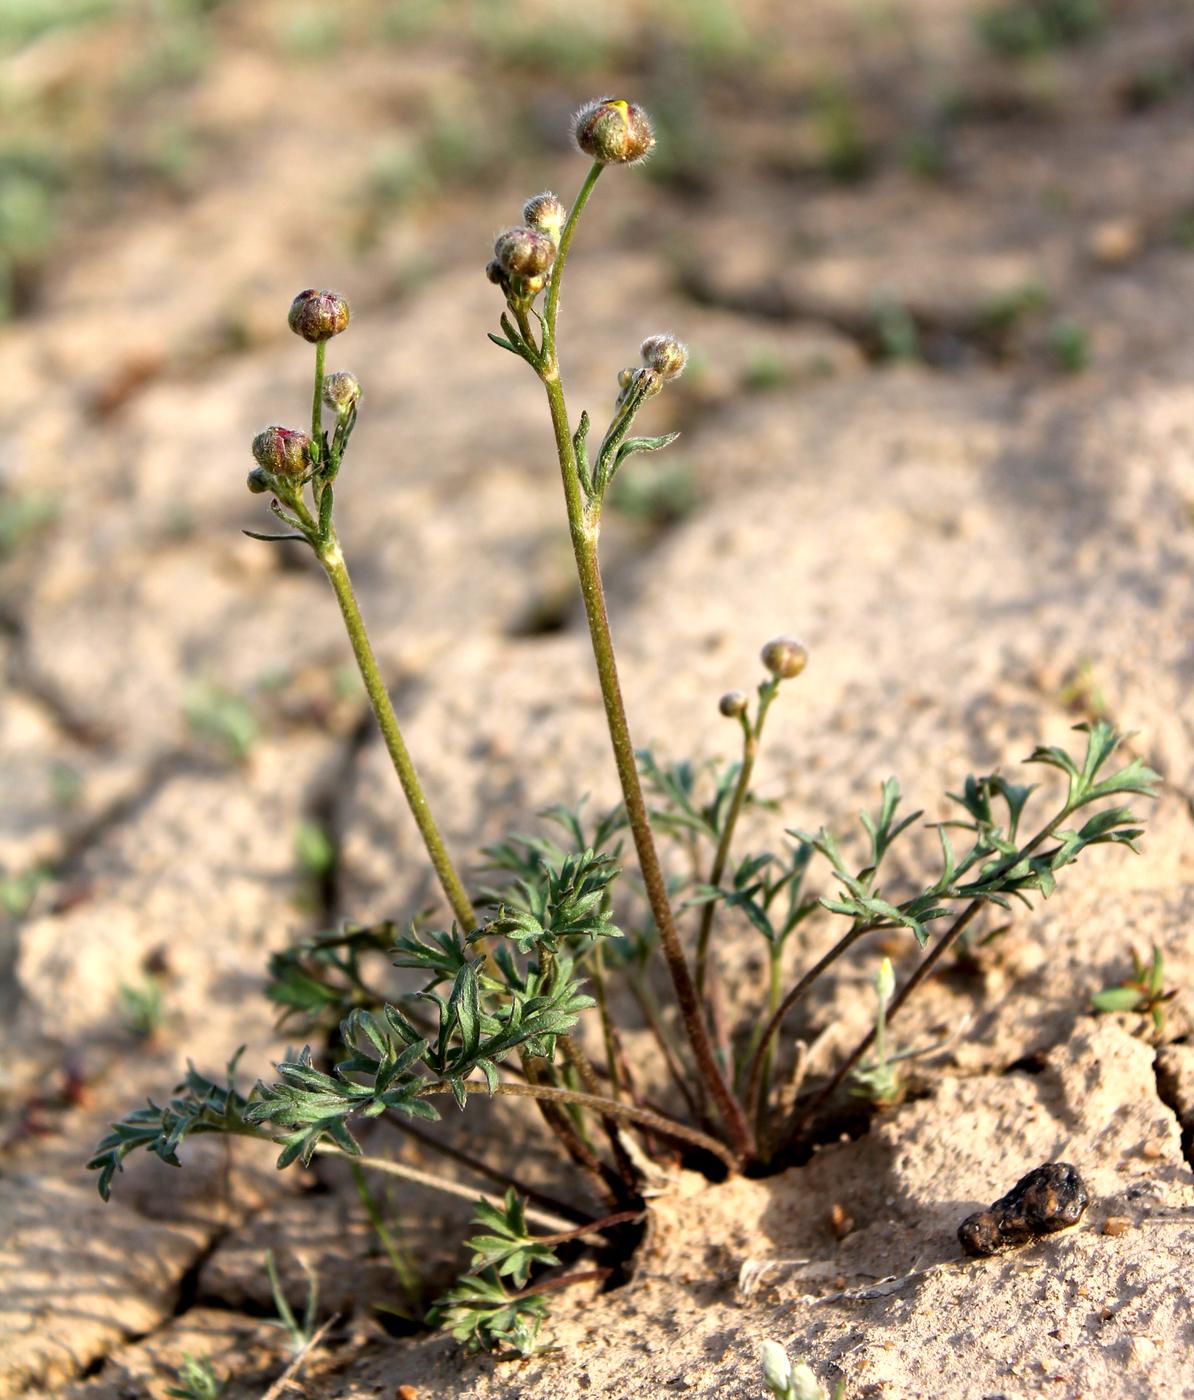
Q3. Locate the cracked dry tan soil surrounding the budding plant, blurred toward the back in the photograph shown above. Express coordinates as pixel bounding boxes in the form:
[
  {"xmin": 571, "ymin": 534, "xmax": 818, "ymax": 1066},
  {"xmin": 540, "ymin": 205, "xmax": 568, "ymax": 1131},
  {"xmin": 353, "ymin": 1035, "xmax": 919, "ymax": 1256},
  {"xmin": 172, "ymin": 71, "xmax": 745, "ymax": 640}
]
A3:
[{"xmin": 0, "ymin": 0, "xmax": 1194, "ymax": 1400}]
